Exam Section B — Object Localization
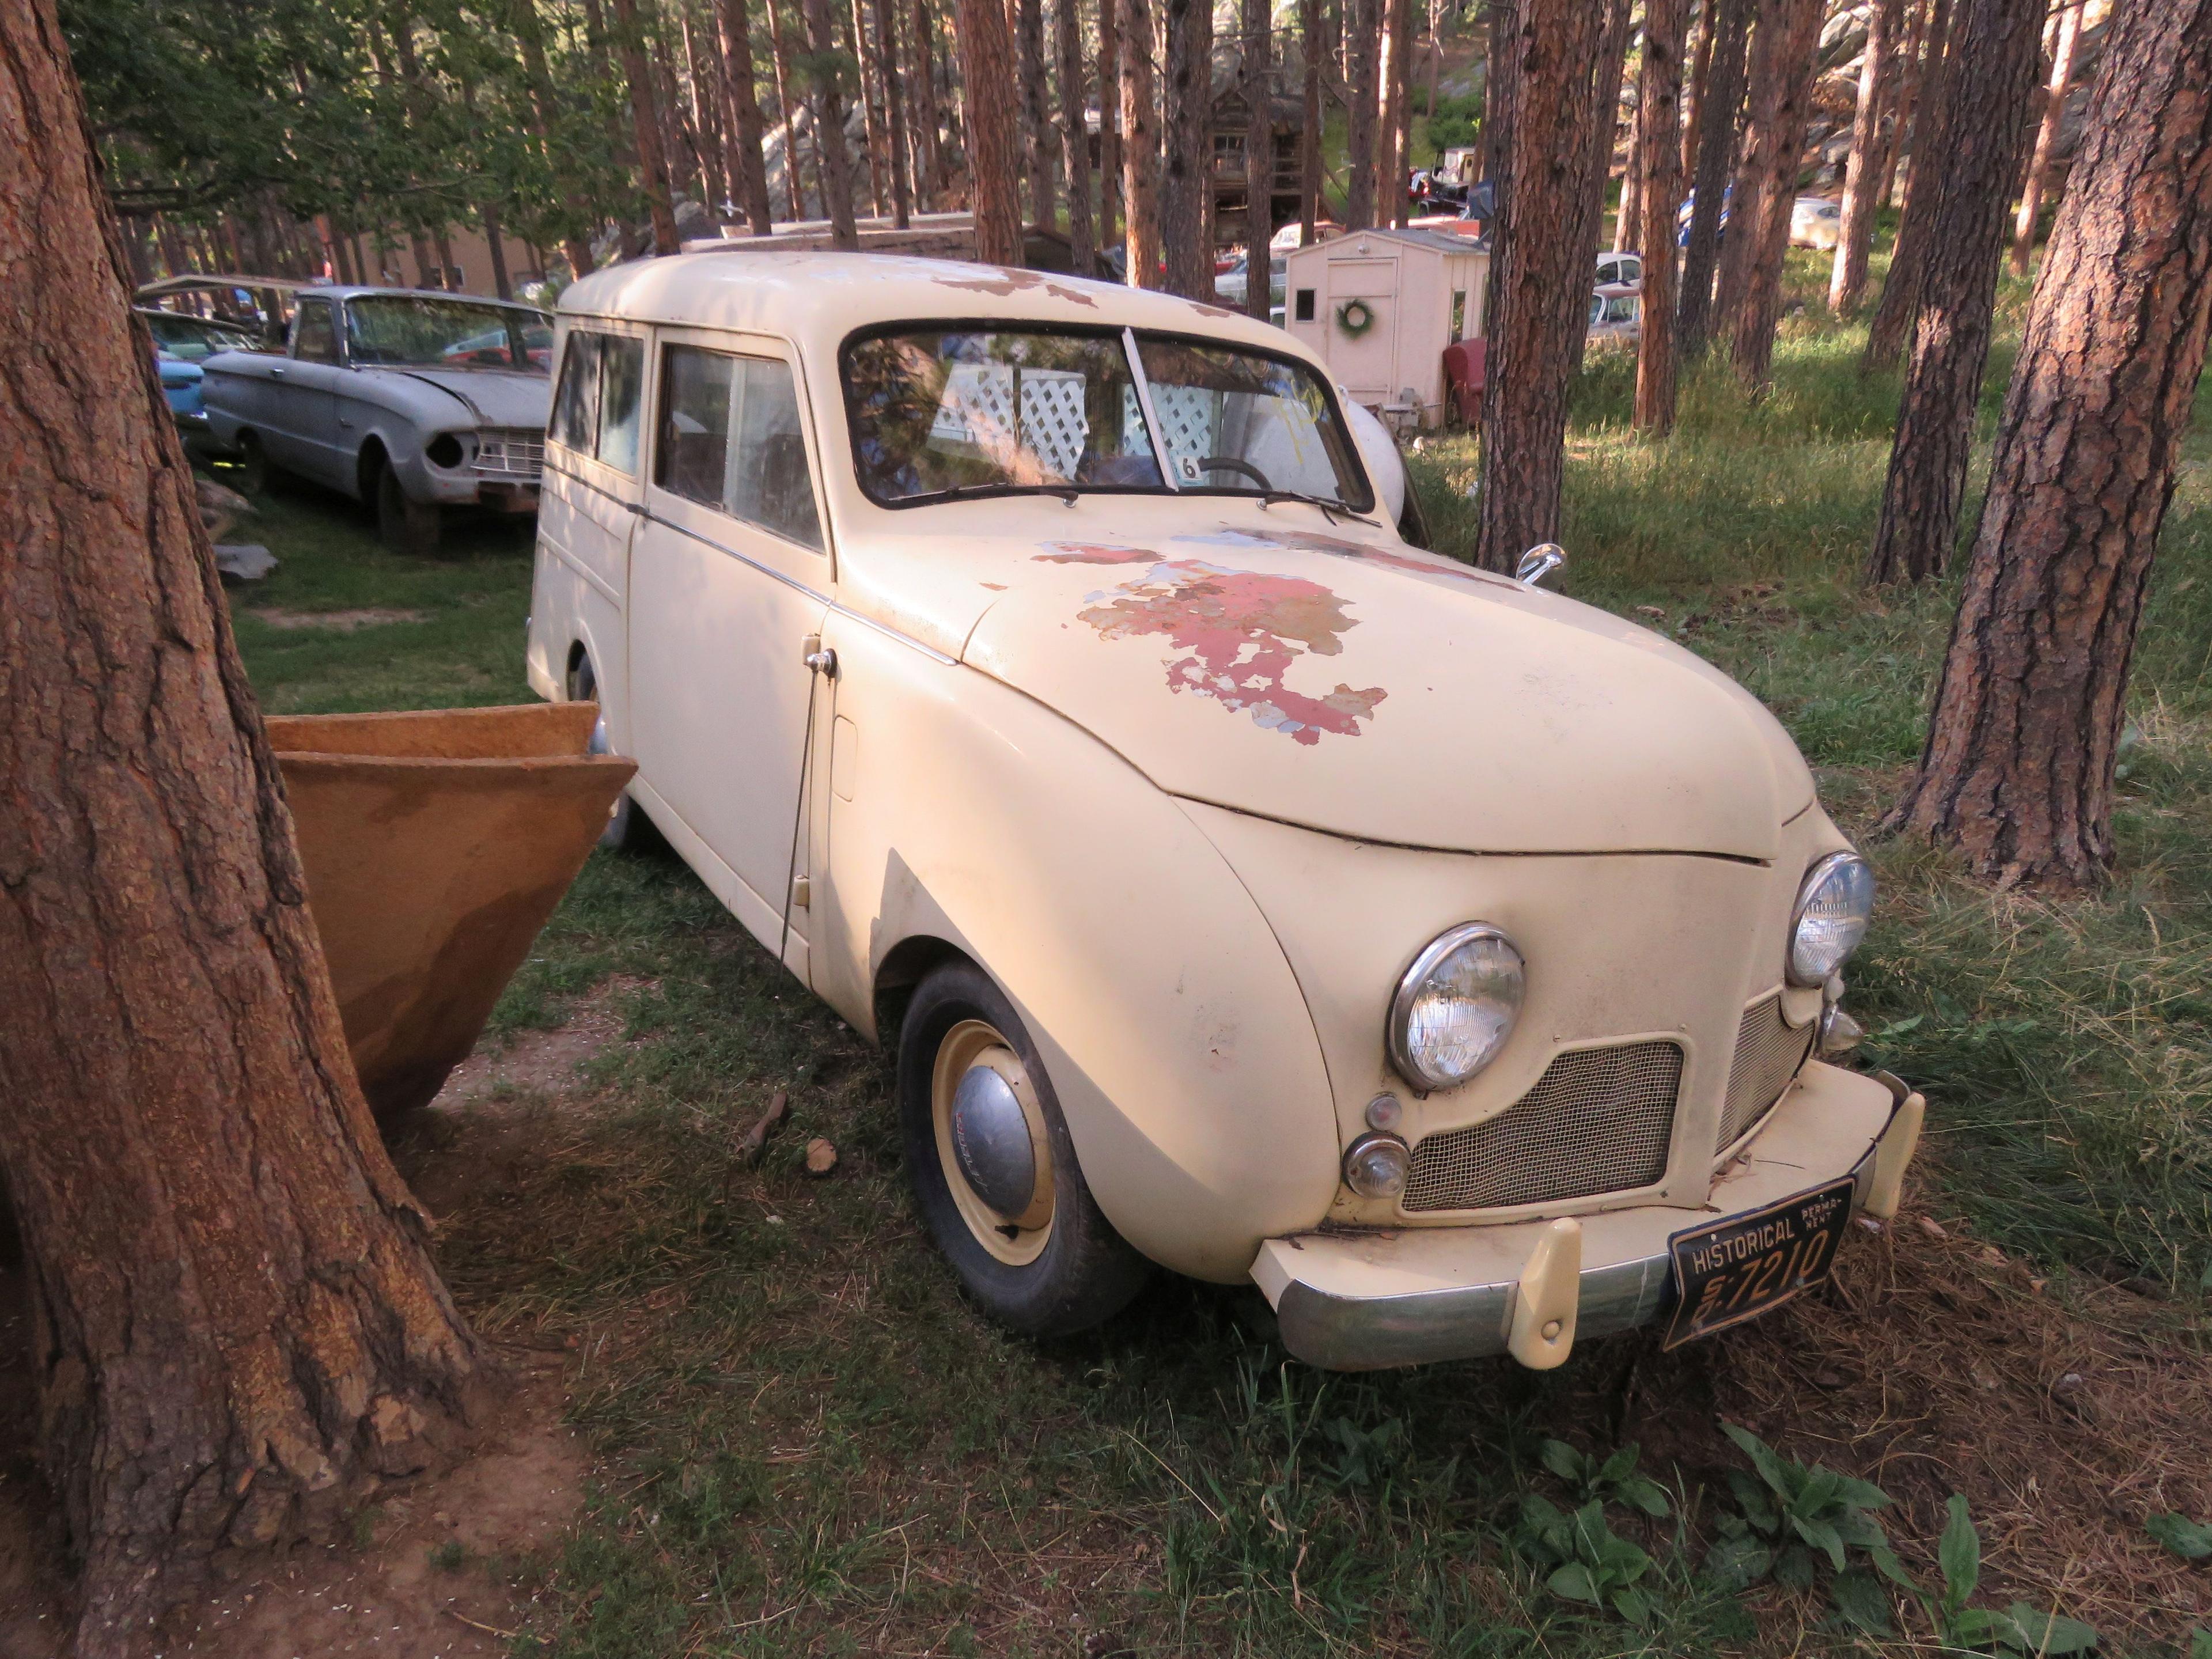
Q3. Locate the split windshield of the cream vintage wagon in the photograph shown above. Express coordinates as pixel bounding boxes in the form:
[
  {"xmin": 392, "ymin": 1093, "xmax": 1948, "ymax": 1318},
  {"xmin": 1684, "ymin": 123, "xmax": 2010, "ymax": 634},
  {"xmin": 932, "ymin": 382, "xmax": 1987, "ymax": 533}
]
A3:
[{"xmin": 845, "ymin": 325, "xmax": 1369, "ymax": 511}]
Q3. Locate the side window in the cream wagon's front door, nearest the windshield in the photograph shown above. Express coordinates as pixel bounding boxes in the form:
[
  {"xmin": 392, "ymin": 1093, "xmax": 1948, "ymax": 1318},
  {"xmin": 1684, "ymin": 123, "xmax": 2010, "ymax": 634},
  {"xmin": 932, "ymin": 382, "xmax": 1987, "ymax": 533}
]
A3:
[{"xmin": 653, "ymin": 345, "xmax": 823, "ymax": 548}]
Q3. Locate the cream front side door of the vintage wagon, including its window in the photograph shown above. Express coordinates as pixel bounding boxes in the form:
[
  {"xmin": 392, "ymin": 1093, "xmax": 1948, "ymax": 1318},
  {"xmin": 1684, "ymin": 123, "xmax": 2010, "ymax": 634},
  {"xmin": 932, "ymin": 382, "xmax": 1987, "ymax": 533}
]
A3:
[{"xmin": 628, "ymin": 329, "xmax": 830, "ymax": 975}]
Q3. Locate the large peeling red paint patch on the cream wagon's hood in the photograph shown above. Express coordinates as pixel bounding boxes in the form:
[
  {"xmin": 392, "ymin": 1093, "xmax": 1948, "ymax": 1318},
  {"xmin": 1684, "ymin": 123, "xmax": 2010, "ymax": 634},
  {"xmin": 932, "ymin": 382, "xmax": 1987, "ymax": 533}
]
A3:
[{"xmin": 1037, "ymin": 555, "xmax": 1389, "ymax": 748}]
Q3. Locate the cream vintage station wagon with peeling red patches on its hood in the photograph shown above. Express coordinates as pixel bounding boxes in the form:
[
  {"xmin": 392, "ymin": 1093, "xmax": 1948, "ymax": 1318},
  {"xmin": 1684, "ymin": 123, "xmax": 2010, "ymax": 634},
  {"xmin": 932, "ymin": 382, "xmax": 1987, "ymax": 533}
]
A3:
[{"xmin": 529, "ymin": 252, "xmax": 1922, "ymax": 1369}]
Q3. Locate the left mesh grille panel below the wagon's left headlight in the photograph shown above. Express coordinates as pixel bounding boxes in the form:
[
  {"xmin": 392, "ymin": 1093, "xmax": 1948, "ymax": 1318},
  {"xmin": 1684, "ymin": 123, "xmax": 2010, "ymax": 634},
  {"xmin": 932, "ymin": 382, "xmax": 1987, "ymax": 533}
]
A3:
[{"xmin": 1404, "ymin": 1042, "xmax": 1681, "ymax": 1210}]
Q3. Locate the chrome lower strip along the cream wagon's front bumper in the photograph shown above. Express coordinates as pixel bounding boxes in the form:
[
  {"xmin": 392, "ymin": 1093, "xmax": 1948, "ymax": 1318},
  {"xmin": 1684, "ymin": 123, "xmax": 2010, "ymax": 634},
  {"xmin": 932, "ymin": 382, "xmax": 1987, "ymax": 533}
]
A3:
[{"xmin": 1274, "ymin": 1128, "xmax": 1889, "ymax": 1372}]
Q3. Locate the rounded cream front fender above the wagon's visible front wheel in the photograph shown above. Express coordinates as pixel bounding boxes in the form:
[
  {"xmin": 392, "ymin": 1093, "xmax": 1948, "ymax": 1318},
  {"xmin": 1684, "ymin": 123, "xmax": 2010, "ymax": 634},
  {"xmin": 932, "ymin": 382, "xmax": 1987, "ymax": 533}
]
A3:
[{"xmin": 809, "ymin": 613, "xmax": 1338, "ymax": 1283}]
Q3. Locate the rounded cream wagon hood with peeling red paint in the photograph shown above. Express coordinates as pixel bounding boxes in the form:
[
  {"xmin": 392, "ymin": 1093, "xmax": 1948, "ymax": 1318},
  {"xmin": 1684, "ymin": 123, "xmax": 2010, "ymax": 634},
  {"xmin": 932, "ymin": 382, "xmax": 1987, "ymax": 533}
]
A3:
[{"xmin": 925, "ymin": 520, "xmax": 1814, "ymax": 861}]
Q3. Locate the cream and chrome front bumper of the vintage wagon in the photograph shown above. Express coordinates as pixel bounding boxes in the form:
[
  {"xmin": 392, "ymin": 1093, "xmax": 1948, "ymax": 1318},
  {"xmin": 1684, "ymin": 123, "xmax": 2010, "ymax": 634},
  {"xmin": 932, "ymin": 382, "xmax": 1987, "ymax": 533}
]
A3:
[{"xmin": 1252, "ymin": 1062, "xmax": 1922, "ymax": 1372}]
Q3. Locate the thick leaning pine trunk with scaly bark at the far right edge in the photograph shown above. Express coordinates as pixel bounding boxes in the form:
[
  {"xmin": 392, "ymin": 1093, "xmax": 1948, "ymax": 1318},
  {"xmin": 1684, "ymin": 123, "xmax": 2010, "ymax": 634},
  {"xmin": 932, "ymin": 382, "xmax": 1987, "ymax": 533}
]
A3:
[{"xmin": 1887, "ymin": 0, "xmax": 2212, "ymax": 887}]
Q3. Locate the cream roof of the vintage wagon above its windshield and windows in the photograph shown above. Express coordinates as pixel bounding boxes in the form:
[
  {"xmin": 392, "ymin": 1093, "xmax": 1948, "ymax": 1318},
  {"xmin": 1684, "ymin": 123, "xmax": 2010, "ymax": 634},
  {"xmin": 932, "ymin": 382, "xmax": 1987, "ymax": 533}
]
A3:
[{"xmin": 560, "ymin": 241, "xmax": 1309, "ymax": 358}]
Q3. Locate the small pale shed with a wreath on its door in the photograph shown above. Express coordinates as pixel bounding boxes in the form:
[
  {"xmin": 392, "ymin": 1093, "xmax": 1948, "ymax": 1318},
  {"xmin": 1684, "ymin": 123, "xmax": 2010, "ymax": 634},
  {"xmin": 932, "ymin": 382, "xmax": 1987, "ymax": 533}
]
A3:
[{"xmin": 1283, "ymin": 230, "xmax": 1491, "ymax": 427}]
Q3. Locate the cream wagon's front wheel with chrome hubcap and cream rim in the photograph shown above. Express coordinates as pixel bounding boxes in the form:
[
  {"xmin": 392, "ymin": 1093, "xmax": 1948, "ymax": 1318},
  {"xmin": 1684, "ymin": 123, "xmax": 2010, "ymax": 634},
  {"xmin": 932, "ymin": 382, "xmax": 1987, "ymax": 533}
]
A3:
[{"xmin": 898, "ymin": 962, "xmax": 1148, "ymax": 1336}]
